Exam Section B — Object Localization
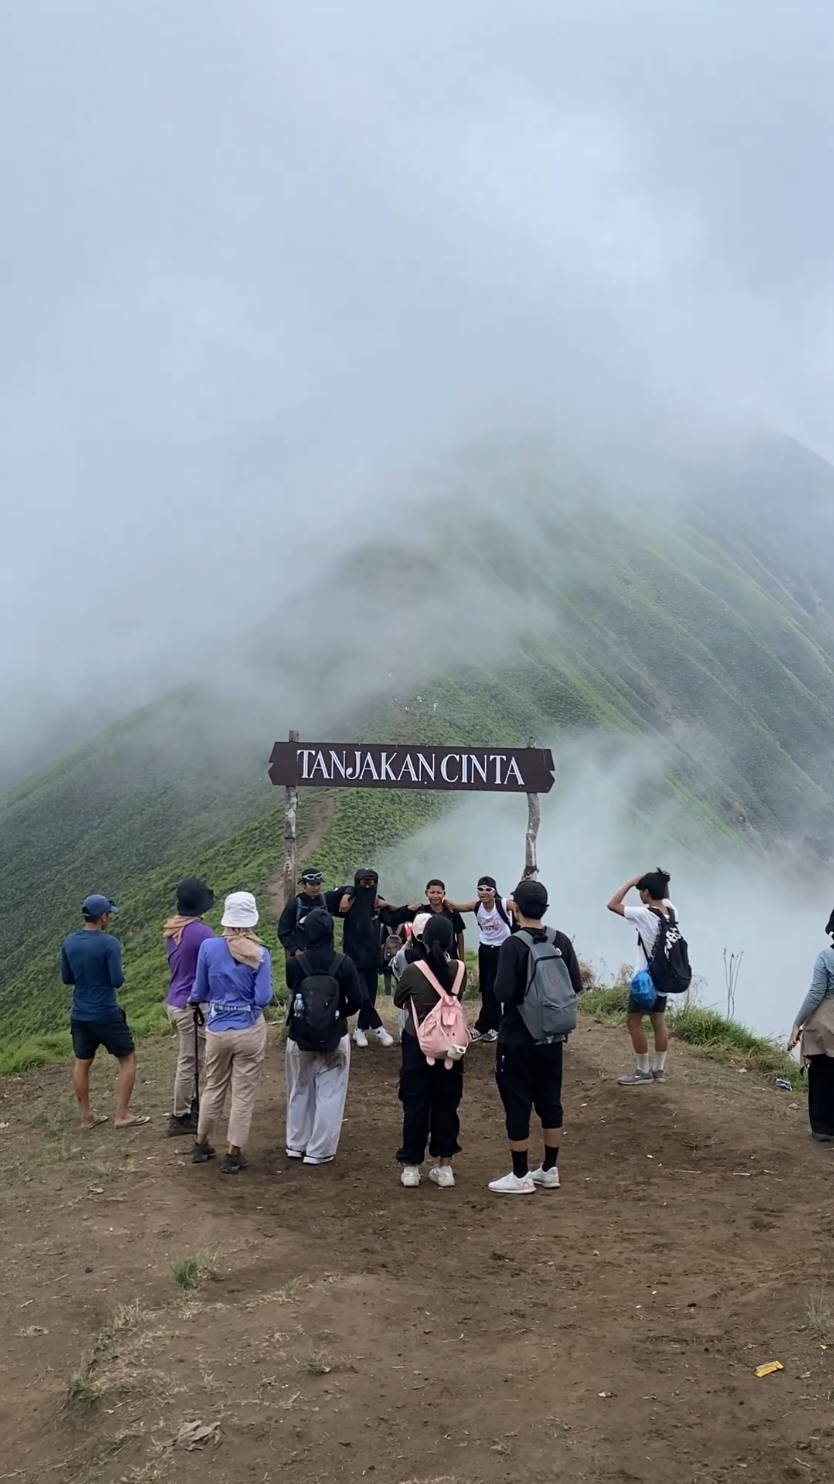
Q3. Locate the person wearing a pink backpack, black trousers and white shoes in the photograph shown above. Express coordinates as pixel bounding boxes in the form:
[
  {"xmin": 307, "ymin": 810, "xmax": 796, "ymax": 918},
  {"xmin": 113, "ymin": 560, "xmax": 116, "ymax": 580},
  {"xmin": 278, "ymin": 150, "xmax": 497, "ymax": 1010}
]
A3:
[{"xmin": 393, "ymin": 913, "xmax": 467, "ymax": 1189}]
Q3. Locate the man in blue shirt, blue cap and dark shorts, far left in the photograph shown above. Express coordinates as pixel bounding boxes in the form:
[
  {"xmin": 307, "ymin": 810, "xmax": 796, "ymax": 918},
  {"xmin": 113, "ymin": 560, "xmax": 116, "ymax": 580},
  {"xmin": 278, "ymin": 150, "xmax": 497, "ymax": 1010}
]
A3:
[{"xmin": 61, "ymin": 893, "xmax": 150, "ymax": 1129}]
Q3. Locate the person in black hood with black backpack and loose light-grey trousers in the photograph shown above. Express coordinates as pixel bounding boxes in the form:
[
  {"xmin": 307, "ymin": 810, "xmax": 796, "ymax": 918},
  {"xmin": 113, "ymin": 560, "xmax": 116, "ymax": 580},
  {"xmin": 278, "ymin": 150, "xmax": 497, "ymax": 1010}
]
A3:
[{"xmin": 286, "ymin": 907, "xmax": 365, "ymax": 1165}]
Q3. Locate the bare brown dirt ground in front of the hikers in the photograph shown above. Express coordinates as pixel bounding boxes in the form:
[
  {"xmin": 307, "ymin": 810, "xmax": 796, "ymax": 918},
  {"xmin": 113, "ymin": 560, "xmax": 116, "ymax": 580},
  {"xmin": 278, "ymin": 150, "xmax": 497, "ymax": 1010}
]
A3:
[{"xmin": 0, "ymin": 1024, "xmax": 834, "ymax": 1484}]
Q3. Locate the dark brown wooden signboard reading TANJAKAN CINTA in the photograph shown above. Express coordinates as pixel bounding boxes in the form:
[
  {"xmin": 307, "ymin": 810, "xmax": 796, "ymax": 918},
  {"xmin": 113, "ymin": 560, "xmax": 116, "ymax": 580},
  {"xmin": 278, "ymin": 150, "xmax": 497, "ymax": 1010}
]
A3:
[{"xmin": 269, "ymin": 742, "xmax": 554, "ymax": 794}]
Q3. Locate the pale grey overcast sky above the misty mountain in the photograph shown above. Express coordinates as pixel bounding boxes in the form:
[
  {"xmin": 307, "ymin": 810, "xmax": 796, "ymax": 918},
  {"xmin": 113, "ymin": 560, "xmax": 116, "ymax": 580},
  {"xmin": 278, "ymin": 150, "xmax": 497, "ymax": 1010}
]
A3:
[{"xmin": 0, "ymin": 0, "xmax": 834, "ymax": 765}]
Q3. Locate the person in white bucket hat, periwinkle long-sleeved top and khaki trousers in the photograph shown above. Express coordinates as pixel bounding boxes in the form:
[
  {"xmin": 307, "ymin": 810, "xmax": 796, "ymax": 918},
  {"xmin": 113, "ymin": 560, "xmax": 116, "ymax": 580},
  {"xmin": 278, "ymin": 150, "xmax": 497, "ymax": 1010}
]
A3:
[{"xmin": 188, "ymin": 892, "xmax": 272, "ymax": 1175}]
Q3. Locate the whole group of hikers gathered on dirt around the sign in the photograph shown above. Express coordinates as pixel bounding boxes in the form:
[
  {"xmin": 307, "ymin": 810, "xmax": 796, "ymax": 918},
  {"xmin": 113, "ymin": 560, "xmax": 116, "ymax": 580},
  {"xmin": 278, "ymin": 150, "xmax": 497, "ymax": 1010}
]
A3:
[{"xmin": 61, "ymin": 868, "xmax": 834, "ymax": 1195}]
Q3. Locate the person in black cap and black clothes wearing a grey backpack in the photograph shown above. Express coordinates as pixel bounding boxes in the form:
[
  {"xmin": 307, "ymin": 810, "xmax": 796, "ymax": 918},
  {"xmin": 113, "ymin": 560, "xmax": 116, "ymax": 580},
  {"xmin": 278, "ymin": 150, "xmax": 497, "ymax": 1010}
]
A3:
[{"xmin": 490, "ymin": 880, "xmax": 583, "ymax": 1196}]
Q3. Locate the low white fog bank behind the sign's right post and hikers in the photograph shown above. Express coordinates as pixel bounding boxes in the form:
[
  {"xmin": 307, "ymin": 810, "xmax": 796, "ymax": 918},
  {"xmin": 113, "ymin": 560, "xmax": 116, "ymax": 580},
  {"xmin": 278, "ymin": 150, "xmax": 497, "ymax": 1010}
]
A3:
[{"xmin": 380, "ymin": 739, "xmax": 834, "ymax": 1039}]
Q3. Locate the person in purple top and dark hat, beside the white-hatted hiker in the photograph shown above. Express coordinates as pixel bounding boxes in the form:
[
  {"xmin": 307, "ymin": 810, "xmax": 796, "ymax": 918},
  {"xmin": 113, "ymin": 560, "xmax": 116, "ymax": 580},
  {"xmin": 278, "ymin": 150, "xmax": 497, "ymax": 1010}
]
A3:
[{"xmin": 162, "ymin": 877, "xmax": 214, "ymax": 1138}]
